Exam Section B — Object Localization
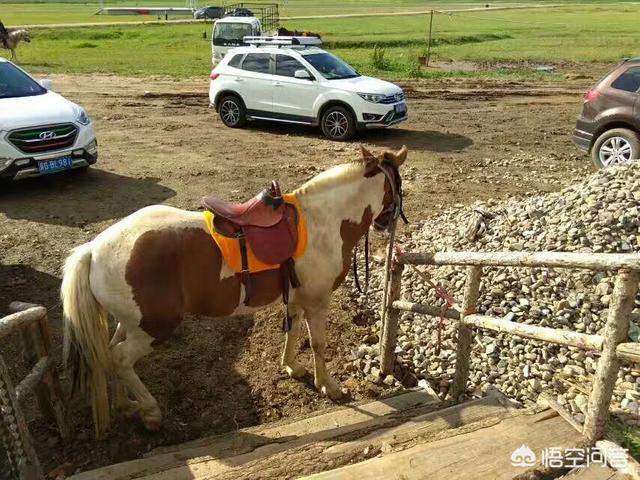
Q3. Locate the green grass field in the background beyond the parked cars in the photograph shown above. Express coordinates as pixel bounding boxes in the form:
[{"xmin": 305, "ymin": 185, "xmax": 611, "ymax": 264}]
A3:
[{"xmin": 0, "ymin": 0, "xmax": 640, "ymax": 79}]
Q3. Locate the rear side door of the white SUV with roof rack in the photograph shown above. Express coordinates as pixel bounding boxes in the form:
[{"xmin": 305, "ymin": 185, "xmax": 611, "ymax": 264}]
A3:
[{"xmin": 232, "ymin": 52, "xmax": 274, "ymax": 116}]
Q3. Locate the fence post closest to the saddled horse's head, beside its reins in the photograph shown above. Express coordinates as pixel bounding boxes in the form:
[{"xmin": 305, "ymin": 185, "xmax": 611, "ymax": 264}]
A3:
[{"xmin": 380, "ymin": 257, "xmax": 404, "ymax": 374}]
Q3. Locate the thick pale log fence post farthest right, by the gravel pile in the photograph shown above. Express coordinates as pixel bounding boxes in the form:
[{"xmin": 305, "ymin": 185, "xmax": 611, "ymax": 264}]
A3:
[{"xmin": 583, "ymin": 270, "xmax": 640, "ymax": 443}]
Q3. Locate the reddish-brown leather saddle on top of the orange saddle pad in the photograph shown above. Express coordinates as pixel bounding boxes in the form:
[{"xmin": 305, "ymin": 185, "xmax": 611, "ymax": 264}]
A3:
[{"xmin": 202, "ymin": 181, "xmax": 300, "ymax": 316}]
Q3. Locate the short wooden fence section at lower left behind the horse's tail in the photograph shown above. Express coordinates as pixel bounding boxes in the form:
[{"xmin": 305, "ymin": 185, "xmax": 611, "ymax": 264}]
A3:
[{"xmin": 0, "ymin": 302, "xmax": 70, "ymax": 480}]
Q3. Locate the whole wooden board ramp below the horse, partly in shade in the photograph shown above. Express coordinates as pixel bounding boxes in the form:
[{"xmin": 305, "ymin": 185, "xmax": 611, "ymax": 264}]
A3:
[{"xmin": 71, "ymin": 391, "xmax": 581, "ymax": 480}]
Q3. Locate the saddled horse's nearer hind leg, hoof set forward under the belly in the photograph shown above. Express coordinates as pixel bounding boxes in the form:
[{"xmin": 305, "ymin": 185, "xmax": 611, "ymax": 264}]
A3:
[{"xmin": 111, "ymin": 326, "xmax": 162, "ymax": 430}]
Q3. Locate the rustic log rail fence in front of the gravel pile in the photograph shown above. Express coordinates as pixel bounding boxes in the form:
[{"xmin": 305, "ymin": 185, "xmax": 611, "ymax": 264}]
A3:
[{"xmin": 380, "ymin": 252, "xmax": 640, "ymax": 442}]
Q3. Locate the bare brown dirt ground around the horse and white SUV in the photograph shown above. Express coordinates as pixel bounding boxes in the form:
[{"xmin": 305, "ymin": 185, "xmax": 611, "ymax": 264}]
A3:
[{"xmin": 0, "ymin": 71, "xmax": 600, "ymax": 472}]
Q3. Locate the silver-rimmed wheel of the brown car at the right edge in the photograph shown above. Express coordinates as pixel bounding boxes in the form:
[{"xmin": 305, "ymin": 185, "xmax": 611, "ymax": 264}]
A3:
[{"xmin": 591, "ymin": 128, "xmax": 640, "ymax": 168}]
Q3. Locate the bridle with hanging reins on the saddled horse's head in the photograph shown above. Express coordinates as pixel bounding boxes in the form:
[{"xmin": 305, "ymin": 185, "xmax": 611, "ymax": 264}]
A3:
[{"xmin": 353, "ymin": 161, "xmax": 409, "ymax": 294}]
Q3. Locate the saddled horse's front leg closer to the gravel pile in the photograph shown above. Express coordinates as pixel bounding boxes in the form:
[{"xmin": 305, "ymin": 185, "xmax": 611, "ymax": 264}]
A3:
[{"xmin": 305, "ymin": 302, "xmax": 342, "ymax": 400}]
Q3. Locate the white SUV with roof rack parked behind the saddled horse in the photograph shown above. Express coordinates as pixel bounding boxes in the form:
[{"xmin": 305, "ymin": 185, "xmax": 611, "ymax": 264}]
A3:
[{"xmin": 209, "ymin": 37, "xmax": 407, "ymax": 140}]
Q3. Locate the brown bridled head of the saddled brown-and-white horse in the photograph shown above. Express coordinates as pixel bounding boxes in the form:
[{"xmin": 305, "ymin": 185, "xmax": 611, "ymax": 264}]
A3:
[{"xmin": 360, "ymin": 146, "xmax": 407, "ymax": 230}]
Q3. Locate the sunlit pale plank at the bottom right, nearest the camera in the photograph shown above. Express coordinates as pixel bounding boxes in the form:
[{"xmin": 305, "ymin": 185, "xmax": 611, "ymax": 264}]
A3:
[{"xmin": 306, "ymin": 412, "xmax": 582, "ymax": 480}]
